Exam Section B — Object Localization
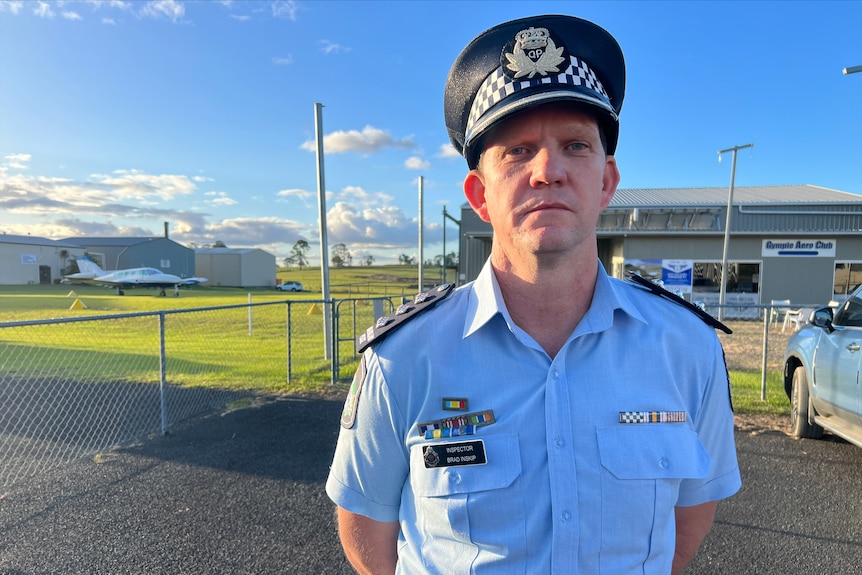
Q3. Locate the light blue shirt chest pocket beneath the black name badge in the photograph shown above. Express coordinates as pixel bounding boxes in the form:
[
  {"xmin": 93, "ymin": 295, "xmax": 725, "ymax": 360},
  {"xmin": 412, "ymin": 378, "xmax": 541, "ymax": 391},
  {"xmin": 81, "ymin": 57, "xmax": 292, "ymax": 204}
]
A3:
[{"xmin": 410, "ymin": 433, "xmax": 526, "ymax": 560}]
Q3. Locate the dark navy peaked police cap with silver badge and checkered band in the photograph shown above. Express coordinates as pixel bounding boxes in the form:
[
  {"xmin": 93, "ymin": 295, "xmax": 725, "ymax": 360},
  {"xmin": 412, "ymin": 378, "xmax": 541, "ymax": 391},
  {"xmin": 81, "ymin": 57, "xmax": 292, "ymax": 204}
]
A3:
[{"xmin": 444, "ymin": 15, "xmax": 625, "ymax": 168}]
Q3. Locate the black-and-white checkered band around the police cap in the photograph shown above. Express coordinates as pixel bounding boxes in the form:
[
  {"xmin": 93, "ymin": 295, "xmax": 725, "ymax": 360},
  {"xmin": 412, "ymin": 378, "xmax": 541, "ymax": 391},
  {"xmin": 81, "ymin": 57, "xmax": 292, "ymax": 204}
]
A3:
[{"xmin": 466, "ymin": 56, "xmax": 616, "ymax": 144}]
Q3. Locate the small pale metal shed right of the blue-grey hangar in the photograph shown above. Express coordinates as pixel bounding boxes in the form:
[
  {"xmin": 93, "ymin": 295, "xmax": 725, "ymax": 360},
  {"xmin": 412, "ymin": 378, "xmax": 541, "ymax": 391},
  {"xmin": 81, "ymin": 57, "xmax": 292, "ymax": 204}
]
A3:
[{"xmin": 195, "ymin": 248, "xmax": 276, "ymax": 287}]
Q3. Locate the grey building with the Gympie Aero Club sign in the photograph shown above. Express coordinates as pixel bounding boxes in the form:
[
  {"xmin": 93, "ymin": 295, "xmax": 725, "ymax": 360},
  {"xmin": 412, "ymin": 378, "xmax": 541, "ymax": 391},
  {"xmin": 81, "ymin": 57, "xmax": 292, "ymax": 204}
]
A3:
[{"xmin": 459, "ymin": 185, "xmax": 862, "ymax": 306}]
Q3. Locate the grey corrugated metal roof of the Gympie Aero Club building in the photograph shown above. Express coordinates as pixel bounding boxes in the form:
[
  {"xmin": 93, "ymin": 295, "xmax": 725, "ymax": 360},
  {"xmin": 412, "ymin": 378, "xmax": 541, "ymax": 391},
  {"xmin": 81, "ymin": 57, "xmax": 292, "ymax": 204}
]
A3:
[{"xmin": 608, "ymin": 184, "xmax": 862, "ymax": 208}]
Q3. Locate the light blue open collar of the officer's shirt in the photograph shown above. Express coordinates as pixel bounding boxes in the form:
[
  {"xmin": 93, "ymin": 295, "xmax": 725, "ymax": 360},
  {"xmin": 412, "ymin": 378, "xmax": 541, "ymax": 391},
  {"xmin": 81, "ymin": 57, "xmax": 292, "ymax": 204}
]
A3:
[{"xmin": 464, "ymin": 259, "xmax": 646, "ymax": 338}]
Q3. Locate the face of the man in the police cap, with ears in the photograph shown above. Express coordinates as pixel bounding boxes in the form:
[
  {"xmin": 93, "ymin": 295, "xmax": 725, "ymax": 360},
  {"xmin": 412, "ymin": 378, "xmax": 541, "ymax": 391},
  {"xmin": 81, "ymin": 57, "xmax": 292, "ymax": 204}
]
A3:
[{"xmin": 464, "ymin": 103, "xmax": 620, "ymax": 260}]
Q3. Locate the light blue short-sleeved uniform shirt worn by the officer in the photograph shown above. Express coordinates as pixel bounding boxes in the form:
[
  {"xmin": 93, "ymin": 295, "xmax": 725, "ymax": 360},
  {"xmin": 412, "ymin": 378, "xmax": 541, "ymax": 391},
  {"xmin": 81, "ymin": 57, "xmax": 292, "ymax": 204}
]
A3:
[{"xmin": 326, "ymin": 264, "xmax": 740, "ymax": 575}]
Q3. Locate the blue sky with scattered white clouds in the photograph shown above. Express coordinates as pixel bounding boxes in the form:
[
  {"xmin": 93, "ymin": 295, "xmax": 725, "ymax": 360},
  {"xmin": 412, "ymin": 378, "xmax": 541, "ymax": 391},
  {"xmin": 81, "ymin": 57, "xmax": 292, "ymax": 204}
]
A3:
[{"xmin": 0, "ymin": 0, "xmax": 862, "ymax": 264}]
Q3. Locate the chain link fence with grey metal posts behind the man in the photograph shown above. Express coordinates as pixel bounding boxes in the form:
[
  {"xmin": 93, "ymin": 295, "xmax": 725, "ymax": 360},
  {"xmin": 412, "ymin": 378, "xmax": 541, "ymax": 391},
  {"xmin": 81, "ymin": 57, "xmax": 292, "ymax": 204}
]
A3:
[{"xmin": 0, "ymin": 296, "xmax": 804, "ymax": 492}]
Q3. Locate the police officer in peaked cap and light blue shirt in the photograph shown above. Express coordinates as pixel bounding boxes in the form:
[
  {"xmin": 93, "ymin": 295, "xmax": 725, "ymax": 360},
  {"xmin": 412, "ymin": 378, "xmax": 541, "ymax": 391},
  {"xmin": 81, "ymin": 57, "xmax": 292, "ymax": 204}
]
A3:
[{"xmin": 326, "ymin": 16, "xmax": 740, "ymax": 575}]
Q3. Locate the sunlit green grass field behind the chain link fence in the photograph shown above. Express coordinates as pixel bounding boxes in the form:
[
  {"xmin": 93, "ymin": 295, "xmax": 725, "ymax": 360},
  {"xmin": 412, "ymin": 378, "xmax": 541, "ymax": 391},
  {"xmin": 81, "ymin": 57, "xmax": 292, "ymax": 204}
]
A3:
[{"xmin": 0, "ymin": 266, "xmax": 789, "ymax": 416}]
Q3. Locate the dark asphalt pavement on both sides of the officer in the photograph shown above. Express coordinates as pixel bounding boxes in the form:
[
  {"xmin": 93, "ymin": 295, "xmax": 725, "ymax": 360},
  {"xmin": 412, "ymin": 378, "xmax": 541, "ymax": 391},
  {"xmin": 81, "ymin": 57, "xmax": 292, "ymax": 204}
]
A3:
[{"xmin": 0, "ymin": 397, "xmax": 862, "ymax": 575}]
